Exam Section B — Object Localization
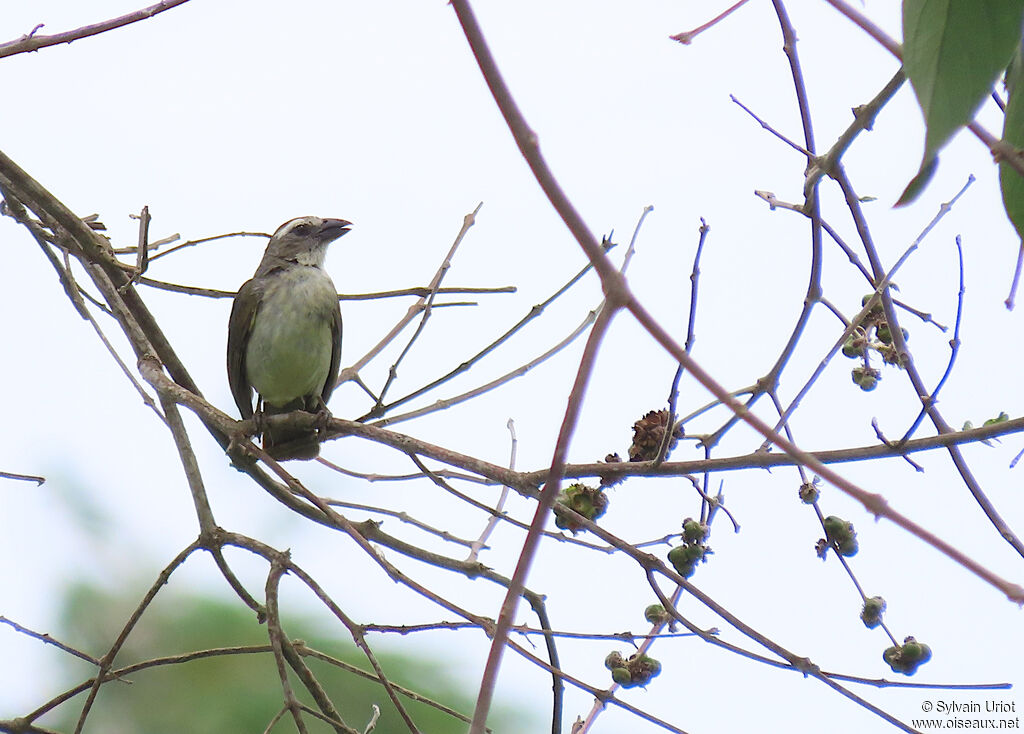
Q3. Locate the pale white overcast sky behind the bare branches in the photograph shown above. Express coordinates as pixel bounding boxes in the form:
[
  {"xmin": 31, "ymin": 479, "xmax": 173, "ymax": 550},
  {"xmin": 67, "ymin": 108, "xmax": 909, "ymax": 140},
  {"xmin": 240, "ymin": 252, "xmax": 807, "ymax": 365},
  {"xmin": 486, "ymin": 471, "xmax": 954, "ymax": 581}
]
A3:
[{"xmin": 0, "ymin": 0, "xmax": 1024, "ymax": 734}]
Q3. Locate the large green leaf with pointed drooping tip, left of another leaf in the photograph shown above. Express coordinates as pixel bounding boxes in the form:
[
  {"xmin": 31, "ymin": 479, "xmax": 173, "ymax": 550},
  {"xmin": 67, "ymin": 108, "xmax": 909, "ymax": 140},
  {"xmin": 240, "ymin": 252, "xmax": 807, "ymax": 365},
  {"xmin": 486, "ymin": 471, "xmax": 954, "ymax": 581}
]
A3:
[{"xmin": 900, "ymin": 0, "xmax": 1024, "ymax": 204}]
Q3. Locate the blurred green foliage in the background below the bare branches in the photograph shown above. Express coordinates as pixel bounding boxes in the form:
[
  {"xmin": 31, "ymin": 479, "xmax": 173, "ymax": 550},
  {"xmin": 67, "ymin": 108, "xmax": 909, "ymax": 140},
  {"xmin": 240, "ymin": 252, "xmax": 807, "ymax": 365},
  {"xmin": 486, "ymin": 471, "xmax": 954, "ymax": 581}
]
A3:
[{"xmin": 42, "ymin": 585, "xmax": 530, "ymax": 734}]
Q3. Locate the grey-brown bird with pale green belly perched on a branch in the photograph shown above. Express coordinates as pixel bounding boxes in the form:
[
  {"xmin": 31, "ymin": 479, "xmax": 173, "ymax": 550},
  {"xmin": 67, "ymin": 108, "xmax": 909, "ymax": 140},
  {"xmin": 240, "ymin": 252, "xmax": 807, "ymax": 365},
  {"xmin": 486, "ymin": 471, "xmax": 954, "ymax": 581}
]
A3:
[{"xmin": 227, "ymin": 217, "xmax": 351, "ymax": 461}]
